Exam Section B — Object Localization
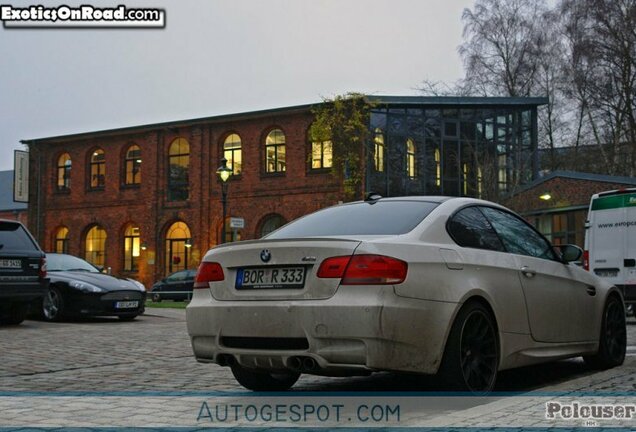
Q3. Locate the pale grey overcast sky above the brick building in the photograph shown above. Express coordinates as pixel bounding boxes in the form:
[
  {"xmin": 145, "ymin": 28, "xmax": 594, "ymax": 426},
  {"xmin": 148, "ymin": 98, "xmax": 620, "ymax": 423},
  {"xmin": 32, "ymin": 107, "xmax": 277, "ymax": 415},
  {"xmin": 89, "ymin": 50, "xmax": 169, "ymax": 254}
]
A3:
[{"xmin": 0, "ymin": 0, "xmax": 474, "ymax": 170}]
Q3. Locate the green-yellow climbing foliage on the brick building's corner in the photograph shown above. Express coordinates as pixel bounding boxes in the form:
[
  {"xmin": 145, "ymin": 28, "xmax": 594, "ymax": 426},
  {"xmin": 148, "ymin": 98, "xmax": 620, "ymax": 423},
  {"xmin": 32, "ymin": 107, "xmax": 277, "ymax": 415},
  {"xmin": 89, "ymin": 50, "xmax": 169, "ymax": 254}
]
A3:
[{"xmin": 309, "ymin": 93, "xmax": 373, "ymax": 201}]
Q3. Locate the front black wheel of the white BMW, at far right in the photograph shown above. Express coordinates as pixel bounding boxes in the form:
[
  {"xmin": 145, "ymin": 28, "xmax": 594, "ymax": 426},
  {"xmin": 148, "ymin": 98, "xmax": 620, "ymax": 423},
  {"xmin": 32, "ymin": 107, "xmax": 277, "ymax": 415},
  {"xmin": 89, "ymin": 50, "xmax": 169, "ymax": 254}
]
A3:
[{"xmin": 583, "ymin": 296, "xmax": 627, "ymax": 369}]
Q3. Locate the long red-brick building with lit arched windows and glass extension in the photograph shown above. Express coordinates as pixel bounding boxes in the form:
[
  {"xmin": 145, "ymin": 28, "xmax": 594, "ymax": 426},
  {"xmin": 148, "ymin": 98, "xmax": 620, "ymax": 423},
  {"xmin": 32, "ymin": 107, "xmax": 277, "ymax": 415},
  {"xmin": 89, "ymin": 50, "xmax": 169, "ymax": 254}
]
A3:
[{"xmin": 23, "ymin": 97, "xmax": 546, "ymax": 286}]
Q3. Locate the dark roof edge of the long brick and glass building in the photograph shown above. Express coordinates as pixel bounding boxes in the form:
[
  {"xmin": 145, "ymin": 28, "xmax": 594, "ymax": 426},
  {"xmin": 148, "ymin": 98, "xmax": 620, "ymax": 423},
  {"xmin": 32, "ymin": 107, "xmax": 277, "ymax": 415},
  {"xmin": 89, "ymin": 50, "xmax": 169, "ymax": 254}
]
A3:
[{"xmin": 20, "ymin": 95, "xmax": 548, "ymax": 145}]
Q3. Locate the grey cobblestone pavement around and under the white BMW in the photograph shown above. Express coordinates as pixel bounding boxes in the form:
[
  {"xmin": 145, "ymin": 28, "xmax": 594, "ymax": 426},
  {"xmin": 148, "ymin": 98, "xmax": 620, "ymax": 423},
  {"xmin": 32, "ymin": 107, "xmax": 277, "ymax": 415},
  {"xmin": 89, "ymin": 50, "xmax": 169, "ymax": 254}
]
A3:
[{"xmin": 0, "ymin": 308, "xmax": 636, "ymax": 429}]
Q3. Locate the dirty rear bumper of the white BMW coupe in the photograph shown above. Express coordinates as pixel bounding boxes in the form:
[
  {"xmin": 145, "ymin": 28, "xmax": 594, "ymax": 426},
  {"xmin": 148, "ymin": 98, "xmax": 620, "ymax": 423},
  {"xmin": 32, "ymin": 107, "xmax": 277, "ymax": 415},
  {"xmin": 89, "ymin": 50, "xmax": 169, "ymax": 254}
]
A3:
[{"xmin": 186, "ymin": 286, "xmax": 458, "ymax": 375}]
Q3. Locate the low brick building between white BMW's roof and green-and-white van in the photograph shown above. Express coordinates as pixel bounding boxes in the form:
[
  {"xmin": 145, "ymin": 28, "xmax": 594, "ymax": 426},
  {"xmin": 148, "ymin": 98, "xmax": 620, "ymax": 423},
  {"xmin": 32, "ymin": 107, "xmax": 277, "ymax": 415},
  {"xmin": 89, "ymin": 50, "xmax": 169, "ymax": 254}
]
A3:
[{"xmin": 502, "ymin": 171, "xmax": 636, "ymax": 248}]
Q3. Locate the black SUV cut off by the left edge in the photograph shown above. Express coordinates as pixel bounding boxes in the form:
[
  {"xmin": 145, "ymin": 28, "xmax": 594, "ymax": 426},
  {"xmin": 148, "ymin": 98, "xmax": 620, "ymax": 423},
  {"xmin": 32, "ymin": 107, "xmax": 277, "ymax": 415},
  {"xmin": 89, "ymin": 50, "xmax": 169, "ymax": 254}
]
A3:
[{"xmin": 0, "ymin": 219, "xmax": 49, "ymax": 324}]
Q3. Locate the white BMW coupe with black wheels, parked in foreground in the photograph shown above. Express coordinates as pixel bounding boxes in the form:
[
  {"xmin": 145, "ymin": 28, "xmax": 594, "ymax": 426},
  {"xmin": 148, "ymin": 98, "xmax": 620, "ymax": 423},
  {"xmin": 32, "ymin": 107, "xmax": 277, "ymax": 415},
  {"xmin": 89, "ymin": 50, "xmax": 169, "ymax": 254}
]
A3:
[{"xmin": 186, "ymin": 196, "xmax": 626, "ymax": 393}]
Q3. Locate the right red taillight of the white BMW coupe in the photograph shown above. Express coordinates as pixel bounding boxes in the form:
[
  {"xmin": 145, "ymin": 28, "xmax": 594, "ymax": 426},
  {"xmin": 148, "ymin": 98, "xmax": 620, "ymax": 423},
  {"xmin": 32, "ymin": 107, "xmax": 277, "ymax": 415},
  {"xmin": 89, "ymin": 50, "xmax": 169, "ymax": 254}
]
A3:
[{"xmin": 318, "ymin": 255, "xmax": 408, "ymax": 285}]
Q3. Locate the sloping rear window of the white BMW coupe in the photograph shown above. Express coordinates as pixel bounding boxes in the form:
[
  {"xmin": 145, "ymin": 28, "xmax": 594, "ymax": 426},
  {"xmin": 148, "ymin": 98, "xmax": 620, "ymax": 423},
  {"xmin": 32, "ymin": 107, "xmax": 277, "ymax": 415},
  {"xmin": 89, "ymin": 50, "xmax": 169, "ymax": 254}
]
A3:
[{"xmin": 265, "ymin": 201, "xmax": 439, "ymax": 239}]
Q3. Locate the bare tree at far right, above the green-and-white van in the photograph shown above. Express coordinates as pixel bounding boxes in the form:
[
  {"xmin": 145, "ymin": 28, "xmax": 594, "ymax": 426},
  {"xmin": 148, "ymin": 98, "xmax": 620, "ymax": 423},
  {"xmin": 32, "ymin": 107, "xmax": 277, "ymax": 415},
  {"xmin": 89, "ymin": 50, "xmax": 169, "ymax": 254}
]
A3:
[{"xmin": 560, "ymin": 0, "xmax": 636, "ymax": 176}]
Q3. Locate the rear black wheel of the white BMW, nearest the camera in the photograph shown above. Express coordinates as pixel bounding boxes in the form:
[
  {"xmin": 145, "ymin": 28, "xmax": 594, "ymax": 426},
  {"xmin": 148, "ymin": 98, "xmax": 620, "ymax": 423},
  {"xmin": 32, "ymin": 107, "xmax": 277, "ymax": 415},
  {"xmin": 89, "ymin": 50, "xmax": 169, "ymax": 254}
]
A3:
[{"xmin": 438, "ymin": 302, "xmax": 499, "ymax": 394}]
